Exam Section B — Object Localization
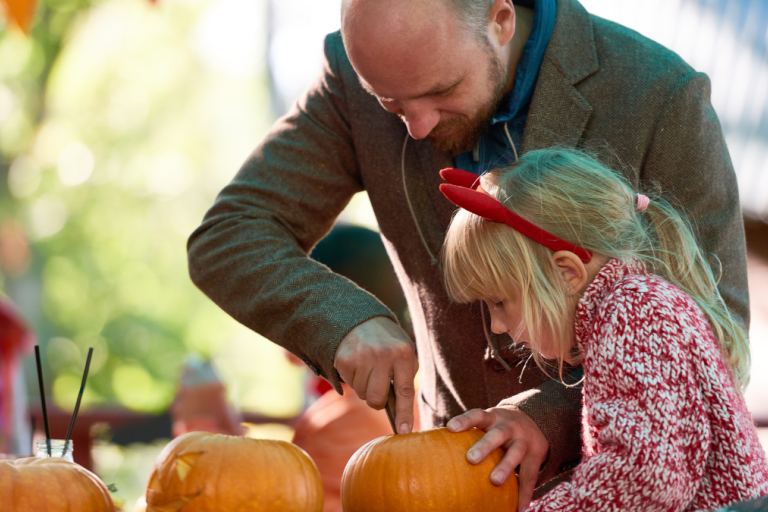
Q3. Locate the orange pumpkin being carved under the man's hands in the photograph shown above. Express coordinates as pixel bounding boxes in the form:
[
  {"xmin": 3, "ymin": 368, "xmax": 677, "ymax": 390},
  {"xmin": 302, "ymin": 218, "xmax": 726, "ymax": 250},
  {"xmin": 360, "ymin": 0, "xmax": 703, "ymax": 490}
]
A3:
[{"xmin": 341, "ymin": 428, "xmax": 517, "ymax": 512}]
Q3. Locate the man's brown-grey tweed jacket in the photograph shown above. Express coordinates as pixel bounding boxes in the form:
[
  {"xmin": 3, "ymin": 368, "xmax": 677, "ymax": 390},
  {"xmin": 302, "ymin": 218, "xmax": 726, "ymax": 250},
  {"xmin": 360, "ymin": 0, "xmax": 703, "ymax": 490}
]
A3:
[{"xmin": 188, "ymin": 0, "xmax": 748, "ymax": 481}]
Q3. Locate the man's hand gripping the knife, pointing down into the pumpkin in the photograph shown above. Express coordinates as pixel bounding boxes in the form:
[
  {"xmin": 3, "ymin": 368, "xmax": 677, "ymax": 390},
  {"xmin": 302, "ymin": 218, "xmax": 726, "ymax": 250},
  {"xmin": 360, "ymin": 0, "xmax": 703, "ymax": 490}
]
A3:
[{"xmin": 333, "ymin": 317, "xmax": 419, "ymax": 434}]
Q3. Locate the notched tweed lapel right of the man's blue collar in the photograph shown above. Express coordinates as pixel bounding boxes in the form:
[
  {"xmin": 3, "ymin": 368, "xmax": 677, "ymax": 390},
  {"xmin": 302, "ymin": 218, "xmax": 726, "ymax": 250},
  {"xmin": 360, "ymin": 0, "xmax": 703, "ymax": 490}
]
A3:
[{"xmin": 522, "ymin": 0, "xmax": 598, "ymax": 153}]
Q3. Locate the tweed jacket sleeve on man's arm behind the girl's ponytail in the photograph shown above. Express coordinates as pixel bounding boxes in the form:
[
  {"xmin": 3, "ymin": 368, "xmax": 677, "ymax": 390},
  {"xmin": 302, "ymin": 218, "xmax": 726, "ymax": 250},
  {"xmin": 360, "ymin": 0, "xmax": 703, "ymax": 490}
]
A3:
[{"xmin": 640, "ymin": 72, "xmax": 749, "ymax": 330}]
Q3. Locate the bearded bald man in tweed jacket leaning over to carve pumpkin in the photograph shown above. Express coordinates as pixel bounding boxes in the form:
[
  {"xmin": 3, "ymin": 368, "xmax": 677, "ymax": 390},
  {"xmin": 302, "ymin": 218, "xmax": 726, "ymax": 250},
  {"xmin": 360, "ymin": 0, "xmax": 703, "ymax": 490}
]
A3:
[{"xmin": 189, "ymin": 0, "xmax": 748, "ymax": 509}]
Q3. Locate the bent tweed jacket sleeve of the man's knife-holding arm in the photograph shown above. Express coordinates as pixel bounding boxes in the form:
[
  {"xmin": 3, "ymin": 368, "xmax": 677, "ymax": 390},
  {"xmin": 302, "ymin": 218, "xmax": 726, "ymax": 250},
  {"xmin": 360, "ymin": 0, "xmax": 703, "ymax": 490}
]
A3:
[{"xmin": 187, "ymin": 35, "xmax": 397, "ymax": 393}]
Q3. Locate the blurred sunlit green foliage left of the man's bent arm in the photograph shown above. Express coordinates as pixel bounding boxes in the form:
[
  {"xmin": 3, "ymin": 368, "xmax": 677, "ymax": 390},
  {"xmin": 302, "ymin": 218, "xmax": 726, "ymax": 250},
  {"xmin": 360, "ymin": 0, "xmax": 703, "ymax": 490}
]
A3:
[{"xmin": 0, "ymin": 0, "xmax": 303, "ymax": 415}]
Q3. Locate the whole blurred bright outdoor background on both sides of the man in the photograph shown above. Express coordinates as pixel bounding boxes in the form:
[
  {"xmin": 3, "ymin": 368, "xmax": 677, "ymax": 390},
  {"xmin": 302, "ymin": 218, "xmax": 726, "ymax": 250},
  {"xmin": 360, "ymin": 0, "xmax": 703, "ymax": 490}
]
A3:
[{"xmin": 0, "ymin": 0, "xmax": 768, "ymax": 510}]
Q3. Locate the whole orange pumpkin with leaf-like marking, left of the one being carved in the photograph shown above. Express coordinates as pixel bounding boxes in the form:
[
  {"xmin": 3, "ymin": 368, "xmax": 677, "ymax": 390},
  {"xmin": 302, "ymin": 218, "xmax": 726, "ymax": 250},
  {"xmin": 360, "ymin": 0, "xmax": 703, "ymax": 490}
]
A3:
[{"xmin": 146, "ymin": 432, "xmax": 323, "ymax": 512}]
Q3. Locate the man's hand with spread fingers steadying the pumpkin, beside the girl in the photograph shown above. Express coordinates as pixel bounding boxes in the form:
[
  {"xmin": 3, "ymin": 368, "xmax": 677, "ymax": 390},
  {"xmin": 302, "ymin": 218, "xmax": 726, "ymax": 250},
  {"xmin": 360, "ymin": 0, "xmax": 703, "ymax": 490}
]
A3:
[{"xmin": 448, "ymin": 407, "xmax": 549, "ymax": 512}]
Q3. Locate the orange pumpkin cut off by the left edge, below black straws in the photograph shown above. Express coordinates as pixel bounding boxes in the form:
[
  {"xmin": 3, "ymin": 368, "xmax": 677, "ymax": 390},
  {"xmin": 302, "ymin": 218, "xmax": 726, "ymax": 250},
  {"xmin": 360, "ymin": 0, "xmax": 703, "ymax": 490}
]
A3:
[{"xmin": 0, "ymin": 457, "xmax": 115, "ymax": 512}]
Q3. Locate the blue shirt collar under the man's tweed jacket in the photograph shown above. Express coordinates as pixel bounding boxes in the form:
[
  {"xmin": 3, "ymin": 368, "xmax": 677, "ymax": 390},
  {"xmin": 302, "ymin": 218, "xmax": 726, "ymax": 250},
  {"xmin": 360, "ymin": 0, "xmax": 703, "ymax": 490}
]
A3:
[{"xmin": 453, "ymin": 0, "xmax": 556, "ymax": 175}]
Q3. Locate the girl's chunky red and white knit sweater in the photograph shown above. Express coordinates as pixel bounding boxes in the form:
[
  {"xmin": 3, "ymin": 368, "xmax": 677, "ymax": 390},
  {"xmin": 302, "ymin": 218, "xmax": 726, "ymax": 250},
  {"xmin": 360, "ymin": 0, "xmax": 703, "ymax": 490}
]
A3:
[{"xmin": 529, "ymin": 260, "xmax": 768, "ymax": 512}]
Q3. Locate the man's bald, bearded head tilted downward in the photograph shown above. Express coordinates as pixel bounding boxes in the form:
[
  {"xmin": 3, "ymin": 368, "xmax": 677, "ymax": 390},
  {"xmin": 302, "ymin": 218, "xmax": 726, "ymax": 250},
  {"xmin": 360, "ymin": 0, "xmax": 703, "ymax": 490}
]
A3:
[{"xmin": 341, "ymin": 0, "xmax": 515, "ymax": 154}]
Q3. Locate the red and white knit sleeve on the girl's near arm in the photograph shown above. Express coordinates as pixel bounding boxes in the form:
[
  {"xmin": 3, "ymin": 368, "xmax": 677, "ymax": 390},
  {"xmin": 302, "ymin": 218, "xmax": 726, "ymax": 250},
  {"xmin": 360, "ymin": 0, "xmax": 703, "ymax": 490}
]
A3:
[{"xmin": 530, "ymin": 290, "xmax": 711, "ymax": 512}]
